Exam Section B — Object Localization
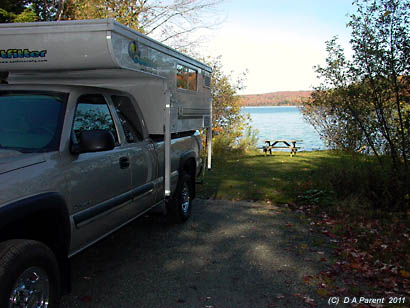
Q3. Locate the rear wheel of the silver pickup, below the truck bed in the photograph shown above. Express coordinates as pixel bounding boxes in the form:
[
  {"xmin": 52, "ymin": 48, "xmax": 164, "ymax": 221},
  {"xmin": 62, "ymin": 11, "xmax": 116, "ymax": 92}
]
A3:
[{"xmin": 167, "ymin": 172, "xmax": 194, "ymax": 224}]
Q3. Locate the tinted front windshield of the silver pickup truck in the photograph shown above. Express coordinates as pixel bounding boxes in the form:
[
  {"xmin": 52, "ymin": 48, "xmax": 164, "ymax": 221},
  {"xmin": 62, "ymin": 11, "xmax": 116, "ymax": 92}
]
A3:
[{"xmin": 0, "ymin": 91, "xmax": 68, "ymax": 153}]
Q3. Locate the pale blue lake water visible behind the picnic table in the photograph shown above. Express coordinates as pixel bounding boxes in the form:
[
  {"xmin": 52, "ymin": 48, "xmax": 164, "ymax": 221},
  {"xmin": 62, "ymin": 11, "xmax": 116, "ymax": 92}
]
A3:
[{"xmin": 242, "ymin": 106, "xmax": 326, "ymax": 151}]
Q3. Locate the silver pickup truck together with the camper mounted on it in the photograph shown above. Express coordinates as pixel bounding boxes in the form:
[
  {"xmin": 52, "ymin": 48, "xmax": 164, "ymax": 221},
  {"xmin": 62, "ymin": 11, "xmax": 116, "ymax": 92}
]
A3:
[{"xmin": 0, "ymin": 19, "xmax": 212, "ymax": 308}]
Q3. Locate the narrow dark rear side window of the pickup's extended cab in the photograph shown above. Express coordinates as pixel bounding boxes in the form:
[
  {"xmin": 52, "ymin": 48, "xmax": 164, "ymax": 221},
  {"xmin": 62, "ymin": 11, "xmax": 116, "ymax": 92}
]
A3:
[{"xmin": 111, "ymin": 95, "xmax": 143, "ymax": 143}]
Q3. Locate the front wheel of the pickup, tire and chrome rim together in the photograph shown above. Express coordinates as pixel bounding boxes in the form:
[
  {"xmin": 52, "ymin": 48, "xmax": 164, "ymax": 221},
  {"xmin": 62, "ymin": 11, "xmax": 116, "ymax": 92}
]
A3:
[{"xmin": 0, "ymin": 240, "xmax": 60, "ymax": 308}]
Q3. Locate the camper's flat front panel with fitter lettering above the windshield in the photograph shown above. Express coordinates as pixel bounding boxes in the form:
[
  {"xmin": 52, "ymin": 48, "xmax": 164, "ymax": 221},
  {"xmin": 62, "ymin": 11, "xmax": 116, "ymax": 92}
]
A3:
[{"xmin": 0, "ymin": 21, "xmax": 118, "ymax": 72}]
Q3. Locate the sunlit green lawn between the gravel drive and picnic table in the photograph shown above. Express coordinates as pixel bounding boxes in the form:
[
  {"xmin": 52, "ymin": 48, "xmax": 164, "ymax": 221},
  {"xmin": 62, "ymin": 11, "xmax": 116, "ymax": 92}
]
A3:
[{"xmin": 198, "ymin": 151, "xmax": 352, "ymax": 203}]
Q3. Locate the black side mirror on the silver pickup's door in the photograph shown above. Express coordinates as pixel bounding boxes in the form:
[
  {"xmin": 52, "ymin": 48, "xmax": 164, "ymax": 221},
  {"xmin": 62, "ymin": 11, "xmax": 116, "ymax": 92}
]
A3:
[{"xmin": 71, "ymin": 129, "xmax": 115, "ymax": 154}]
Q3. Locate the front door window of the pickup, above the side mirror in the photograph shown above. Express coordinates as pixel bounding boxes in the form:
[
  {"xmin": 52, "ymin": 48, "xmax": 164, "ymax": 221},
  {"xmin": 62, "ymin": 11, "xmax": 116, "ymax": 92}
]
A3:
[{"xmin": 73, "ymin": 94, "xmax": 118, "ymax": 144}]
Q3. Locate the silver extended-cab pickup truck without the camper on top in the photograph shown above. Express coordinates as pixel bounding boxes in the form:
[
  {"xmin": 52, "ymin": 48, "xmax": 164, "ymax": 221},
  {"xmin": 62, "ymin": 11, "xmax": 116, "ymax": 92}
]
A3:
[{"xmin": 0, "ymin": 85, "xmax": 201, "ymax": 308}]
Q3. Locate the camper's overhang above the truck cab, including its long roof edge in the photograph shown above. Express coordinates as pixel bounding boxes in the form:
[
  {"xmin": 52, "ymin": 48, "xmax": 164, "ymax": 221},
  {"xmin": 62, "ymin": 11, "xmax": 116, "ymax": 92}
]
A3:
[{"xmin": 0, "ymin": 19, "xmax": 211, "ymax": 75}]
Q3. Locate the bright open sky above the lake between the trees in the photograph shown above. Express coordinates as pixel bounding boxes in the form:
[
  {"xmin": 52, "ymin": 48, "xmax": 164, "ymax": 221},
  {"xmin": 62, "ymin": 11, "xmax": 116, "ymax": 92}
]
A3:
[{"xmin": 206, "ymin": 0, "xmax": 353, "ymax": 94}]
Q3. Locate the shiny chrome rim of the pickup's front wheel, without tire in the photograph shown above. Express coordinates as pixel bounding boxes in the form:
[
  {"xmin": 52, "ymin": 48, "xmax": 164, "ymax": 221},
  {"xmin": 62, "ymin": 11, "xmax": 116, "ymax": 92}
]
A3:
[{"xmin": 9, "ymin": 266, "xmax": 50, "ymax": 308}]
